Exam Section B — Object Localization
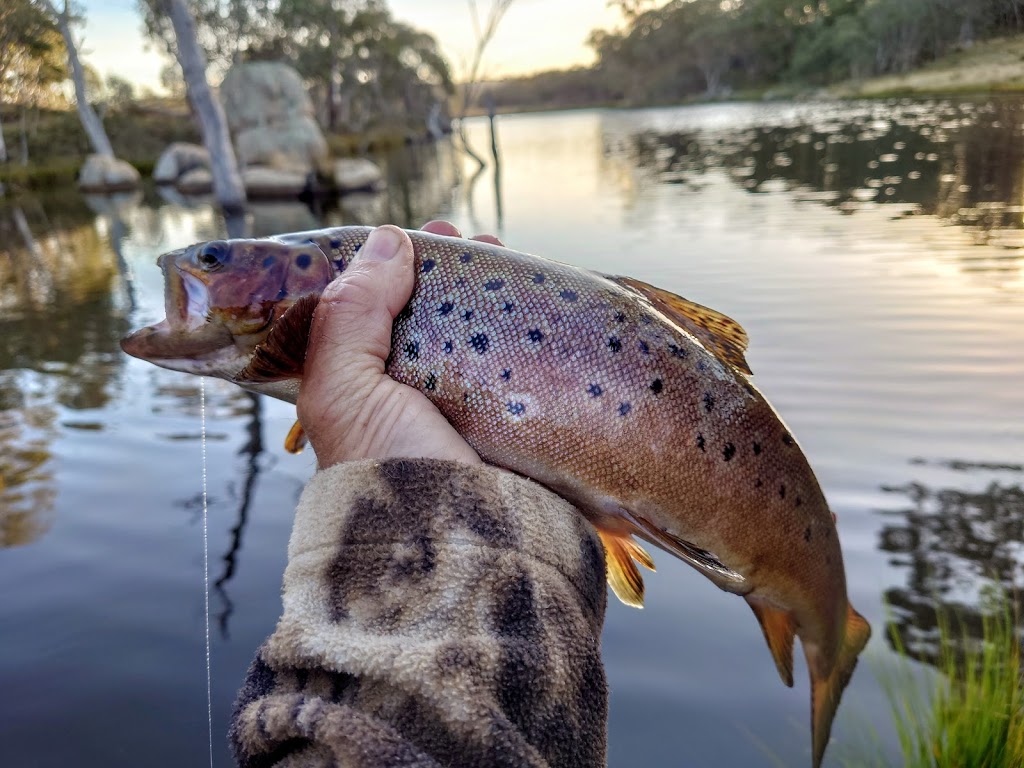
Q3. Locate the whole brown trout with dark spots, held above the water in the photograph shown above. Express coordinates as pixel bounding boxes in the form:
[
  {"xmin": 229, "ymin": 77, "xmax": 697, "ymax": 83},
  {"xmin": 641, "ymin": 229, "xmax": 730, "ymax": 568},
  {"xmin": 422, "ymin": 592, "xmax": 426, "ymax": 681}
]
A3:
[{"xmin": 122, "ymin": 226, "xmax": 870, "ymax": 766}]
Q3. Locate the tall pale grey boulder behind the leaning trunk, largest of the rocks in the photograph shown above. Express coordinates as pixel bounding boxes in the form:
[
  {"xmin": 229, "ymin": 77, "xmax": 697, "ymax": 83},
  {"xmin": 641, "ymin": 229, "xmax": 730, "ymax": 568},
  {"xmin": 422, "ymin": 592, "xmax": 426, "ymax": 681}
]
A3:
[{"xmin": 220, "ymin": 61, "xmax": 328, "ymax": 174}]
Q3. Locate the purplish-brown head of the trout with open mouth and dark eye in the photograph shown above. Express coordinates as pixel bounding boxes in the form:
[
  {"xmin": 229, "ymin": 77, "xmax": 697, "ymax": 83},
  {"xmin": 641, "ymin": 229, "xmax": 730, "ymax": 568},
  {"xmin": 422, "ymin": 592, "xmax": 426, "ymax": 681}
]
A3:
[{"xmin": 121, "ymin": 240, "xmax": 334, "ymax": 380}]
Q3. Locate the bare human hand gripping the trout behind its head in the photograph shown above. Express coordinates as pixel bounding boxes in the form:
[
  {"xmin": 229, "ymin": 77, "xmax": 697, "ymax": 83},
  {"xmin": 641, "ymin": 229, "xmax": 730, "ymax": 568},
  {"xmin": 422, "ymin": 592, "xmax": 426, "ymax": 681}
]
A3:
[{"xmin": 297, "ymin": 221, "xmax": 501, "ymax": 468}]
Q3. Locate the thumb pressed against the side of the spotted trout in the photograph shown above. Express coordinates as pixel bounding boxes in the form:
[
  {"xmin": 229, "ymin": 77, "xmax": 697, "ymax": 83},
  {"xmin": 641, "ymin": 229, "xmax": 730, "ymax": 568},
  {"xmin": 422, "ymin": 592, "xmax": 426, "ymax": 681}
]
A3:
[{"xmin": 298, "ymin": 225, "xmax": 415, "ymax": 434}]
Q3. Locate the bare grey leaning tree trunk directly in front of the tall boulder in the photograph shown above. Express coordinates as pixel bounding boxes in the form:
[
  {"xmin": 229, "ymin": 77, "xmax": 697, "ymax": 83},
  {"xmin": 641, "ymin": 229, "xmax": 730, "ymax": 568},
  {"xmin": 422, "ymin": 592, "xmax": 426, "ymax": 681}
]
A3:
[{"xmin": 164, "ymin": 0, "xmax": 246, "ymax": 212}]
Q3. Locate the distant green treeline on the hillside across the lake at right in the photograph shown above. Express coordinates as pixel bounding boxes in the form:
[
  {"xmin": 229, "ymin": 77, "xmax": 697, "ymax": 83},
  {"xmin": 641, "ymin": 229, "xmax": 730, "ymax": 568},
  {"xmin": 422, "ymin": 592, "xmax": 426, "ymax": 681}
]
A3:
[{"xmin": 490, "ymin": 0, "xmax": 1024, "ymax": 110}]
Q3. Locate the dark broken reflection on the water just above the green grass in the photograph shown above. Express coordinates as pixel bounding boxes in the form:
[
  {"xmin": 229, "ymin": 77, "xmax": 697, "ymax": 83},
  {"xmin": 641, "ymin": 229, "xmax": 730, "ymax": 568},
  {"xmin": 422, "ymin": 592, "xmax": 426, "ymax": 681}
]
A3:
[{"xmin": 879, "ymin": 461, "xmax": 1024, "ymax": 665}]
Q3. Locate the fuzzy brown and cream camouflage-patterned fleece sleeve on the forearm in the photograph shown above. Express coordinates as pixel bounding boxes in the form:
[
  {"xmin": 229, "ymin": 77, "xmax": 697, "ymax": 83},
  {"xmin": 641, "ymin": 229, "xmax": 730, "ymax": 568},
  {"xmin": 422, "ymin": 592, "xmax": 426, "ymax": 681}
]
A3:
[{"xmin": 230, "ymin": 460, "xmax": 607, "ymax": 768}]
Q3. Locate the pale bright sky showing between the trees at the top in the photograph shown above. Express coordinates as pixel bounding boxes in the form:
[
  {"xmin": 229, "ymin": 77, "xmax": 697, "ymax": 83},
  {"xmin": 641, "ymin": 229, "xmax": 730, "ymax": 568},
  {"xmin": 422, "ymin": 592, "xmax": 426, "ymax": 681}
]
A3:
[{"xmin": 80, "ymin": 0, "xmax": 618, "ymax": 91}]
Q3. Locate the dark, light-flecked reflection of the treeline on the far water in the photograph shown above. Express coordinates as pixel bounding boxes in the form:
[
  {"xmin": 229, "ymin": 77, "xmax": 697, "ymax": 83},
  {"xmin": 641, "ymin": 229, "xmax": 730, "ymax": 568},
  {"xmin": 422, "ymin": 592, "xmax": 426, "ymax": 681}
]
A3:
[{"xmin": 604, "ymin": 99, "xmax": 1024, "ymax": 282}]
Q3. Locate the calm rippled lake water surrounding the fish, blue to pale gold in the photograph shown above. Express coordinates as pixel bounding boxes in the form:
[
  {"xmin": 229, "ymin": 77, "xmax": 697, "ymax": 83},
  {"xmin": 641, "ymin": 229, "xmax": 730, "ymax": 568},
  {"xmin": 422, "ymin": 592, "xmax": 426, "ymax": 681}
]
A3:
[{"xmin": 0, "ymin": 100, "xmax": 1024, "ymax": 768}]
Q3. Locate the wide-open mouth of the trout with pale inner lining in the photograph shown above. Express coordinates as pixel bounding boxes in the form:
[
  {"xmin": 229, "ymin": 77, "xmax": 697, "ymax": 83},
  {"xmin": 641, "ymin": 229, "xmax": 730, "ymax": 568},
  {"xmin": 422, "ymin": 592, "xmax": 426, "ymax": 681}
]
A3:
[{"xmin": 121, "ymin": 249, "xmax": 232, "ymax": 368}]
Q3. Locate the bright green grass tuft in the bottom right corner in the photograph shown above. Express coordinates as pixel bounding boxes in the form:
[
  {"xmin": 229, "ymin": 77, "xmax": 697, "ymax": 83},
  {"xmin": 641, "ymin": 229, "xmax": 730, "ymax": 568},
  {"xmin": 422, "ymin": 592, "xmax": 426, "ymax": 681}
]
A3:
[{"xmin": 883, "ymin": 598, "xmax": 1024, "ymax": 768}]
